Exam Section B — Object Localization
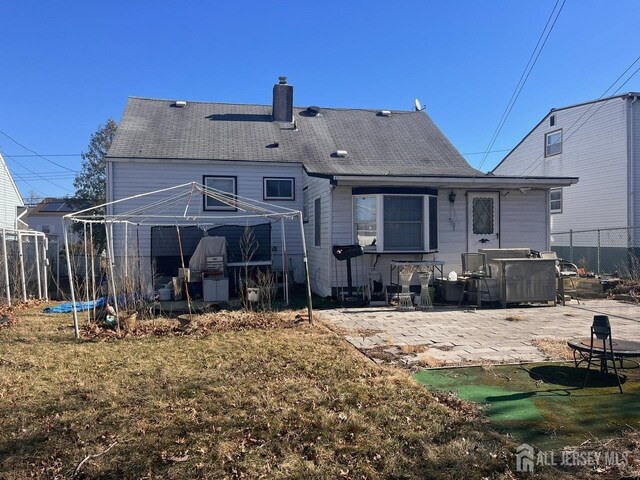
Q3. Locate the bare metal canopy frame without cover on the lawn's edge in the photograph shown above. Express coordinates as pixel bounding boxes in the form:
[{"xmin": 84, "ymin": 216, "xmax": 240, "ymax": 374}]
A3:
[{"xmin": 63, "ymin": 182, "xmax": 313, "ymax": 338}]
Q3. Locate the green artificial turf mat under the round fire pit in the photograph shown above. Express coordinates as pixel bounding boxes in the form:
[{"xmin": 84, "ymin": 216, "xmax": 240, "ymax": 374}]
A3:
[{"xmin": 415, "ymin": 363, "xmax": 640, "ymax": 449}]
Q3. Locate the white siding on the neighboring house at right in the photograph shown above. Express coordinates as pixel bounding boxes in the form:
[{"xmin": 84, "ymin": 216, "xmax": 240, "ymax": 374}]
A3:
[{"xmin": 494, "ymin": 98, "xmax": 624, "ymax": 232}]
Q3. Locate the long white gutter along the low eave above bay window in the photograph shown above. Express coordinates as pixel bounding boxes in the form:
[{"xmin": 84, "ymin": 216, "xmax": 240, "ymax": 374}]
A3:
[{"xmin": 333, "ymin": 175, "xmax": 578, "ymax": 188}]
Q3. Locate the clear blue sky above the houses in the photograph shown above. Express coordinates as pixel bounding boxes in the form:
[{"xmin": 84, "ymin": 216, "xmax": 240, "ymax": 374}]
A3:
[{"xmin": 0, "ymin": 0, "xmax": 640, "ymax": 196}]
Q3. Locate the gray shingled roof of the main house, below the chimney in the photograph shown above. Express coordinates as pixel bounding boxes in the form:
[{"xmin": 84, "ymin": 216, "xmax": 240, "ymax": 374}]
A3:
[{"xmin": 108, "ymin": 97, "xmax": 484, "ymax": 176}]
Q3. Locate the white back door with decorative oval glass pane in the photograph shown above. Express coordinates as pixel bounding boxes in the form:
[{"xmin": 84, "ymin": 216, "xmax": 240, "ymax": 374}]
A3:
[{"xmin": 467, "ymin": 192, "xmax": 500, "ymax": 252}]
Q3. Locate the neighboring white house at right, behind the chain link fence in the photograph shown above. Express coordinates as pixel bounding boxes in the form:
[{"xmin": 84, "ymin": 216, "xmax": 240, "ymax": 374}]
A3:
[{"xmin": 493, "ymin": 93, "xmax": 640, "ymax": 232}]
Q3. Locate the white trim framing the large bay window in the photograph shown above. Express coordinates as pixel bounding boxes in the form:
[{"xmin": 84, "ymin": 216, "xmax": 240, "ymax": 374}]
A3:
[{"xmin": 351, "ymin": 193, "xmax": 440, "ymax": 254}]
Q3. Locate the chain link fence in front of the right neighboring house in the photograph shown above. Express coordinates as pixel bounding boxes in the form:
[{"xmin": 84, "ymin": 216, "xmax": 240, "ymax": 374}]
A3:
[{"xmin": 551, "ymin": 228, "xmax": 640, "ymax": 278}]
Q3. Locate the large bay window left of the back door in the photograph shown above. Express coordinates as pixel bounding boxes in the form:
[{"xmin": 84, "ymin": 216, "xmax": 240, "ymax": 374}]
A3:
[{"xmin": 353, "ymin": 187, "xmax": 438, "ymax": 252}]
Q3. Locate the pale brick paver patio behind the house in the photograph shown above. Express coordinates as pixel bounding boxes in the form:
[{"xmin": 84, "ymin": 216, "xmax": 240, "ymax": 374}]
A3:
[{"xmin": 319, "ymin": 299, "xmax": 640, "ymax": 365}]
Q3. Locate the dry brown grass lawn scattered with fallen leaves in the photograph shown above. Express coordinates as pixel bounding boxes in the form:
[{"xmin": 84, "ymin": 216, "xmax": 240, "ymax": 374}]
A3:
[{"xmin": 0, "ymin": 310, "xmax": 558, "ymax": 479}]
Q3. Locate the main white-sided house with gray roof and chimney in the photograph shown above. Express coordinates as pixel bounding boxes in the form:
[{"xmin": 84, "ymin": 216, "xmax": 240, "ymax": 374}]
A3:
[{"xmin": 106, "ymin": 79, "xmax": 577, "ymax": 296}]
